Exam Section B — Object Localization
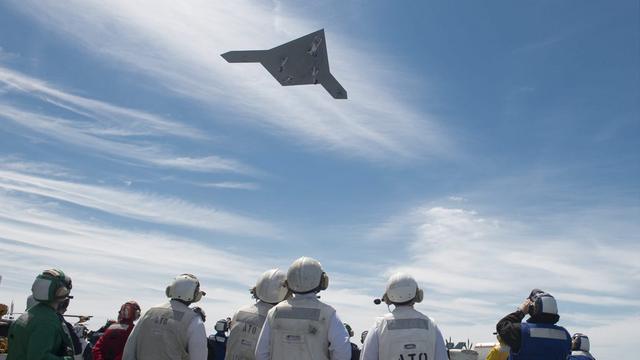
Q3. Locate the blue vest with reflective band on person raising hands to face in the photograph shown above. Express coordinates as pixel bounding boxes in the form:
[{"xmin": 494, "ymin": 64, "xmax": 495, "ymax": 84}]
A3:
[{"xmin": 509, "ymin": 323, "xmax": 571, "ymax": 360}]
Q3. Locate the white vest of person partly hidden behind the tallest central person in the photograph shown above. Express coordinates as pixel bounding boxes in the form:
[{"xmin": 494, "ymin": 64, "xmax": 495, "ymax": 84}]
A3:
[{"xmin": 225, "ymin": 301, "xmax": 273, "ymax": 360}]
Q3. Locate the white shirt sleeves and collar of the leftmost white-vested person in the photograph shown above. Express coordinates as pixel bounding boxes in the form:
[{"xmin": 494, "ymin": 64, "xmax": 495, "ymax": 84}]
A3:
[{"xmin": 122, "ymin": 300, "xmax": 207, "ymax": 360}]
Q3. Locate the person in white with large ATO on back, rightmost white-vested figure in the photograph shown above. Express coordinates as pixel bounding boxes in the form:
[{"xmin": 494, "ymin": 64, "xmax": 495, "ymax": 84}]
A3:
[{"xmin": 360, "ymin": 273, "xmax": 448, "ymax": 360}]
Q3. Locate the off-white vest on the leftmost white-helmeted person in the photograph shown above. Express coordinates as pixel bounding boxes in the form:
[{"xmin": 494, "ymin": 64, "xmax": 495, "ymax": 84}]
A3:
[{"xmin": 135, "ymin": 303, "xmax": 198, "ymax": 360}]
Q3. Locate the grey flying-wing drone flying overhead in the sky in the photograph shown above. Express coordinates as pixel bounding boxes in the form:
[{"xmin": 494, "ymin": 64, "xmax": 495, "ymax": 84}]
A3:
[{"xmin": 222, "ymin": 29, "xmax": 347, "ymax": 99}]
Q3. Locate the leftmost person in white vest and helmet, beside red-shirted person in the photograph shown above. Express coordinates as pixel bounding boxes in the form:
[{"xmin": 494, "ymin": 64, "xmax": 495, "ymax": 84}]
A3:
[{"xmin": 122, "ymin": 274, "xmax": 207, "ymax": 360}]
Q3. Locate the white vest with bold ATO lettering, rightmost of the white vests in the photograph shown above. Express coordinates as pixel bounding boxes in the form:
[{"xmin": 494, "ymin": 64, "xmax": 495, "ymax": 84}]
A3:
[{"xmin": 376, "ymin": 306, "xmax": 437, "ymax": 360}]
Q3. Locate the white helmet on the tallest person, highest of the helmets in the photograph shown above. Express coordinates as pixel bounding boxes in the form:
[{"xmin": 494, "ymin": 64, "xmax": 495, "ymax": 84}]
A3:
[{"xmin": 287, "ymin": 256, "xmax": 329, "ymax": 294}]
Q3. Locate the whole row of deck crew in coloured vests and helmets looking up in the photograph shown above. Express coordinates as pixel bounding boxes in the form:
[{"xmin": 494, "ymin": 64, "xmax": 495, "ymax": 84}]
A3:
[{"xmin": 2, "ymin": 257, "xmax": 593, "ymax": 360}]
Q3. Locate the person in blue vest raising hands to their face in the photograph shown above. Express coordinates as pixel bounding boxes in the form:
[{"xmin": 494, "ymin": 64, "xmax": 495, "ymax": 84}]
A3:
[{"xmin": 496, "ymin": 289, "xmax": 571, "ymax": 360}]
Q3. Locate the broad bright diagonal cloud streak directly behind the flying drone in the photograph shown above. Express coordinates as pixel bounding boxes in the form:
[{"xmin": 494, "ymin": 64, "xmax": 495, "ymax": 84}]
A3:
[{"xmin": 7, "ymin": 1, "xmax": 453, "ymax": 161}]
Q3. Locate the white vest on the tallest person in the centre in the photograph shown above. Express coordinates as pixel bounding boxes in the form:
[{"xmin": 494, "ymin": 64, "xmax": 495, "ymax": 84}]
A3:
[{"xmin": 267, "ymin": 294, "xmax": 336, "ymax": 360}]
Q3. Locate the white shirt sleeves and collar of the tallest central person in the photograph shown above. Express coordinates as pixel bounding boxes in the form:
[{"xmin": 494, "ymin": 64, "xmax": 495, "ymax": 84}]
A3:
[{"xmin": 256, "ymin": 293, "xmax": 351, "ymax": 360}]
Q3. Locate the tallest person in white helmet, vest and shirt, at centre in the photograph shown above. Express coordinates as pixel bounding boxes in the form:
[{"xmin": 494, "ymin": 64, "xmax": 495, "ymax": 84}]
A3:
[{"xmin": 255, "ymin": 257, "xmax": 351, "ymax": 360}]
